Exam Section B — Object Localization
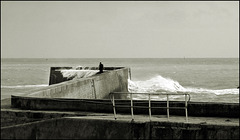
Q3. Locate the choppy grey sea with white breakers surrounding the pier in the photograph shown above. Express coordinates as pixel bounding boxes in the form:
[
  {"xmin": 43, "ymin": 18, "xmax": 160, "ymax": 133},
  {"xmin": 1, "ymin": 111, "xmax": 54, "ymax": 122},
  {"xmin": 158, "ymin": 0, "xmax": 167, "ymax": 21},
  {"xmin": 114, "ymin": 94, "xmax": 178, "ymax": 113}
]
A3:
[{"xmin": 1, "ymin": 58, "xmax": 239, "ymax": 103}]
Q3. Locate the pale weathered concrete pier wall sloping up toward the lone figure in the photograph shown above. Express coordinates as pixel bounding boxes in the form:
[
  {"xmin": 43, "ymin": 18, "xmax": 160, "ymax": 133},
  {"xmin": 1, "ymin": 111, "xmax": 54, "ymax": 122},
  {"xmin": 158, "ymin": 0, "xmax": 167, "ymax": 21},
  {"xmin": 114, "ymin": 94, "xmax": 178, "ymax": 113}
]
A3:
[{"xmin": 19, "ymin": 68, "xmax": 129, "ymax": 99}]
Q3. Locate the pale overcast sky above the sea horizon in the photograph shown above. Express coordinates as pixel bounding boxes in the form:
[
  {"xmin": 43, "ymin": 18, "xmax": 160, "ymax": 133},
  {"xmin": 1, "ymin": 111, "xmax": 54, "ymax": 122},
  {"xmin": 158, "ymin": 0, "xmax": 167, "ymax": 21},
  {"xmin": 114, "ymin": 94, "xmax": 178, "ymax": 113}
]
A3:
[{"xmin": 1, "ymin": 1, "xmax": 239, "ymax": 58}]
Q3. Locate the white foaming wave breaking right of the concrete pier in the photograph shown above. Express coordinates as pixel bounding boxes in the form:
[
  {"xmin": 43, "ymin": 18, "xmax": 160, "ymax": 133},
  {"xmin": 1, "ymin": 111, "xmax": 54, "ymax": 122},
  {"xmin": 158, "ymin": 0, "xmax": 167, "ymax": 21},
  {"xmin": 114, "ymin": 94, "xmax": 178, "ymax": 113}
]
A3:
[{"xmin": 128, "ymin": 75, "xmax": 239, "ymax": 95}]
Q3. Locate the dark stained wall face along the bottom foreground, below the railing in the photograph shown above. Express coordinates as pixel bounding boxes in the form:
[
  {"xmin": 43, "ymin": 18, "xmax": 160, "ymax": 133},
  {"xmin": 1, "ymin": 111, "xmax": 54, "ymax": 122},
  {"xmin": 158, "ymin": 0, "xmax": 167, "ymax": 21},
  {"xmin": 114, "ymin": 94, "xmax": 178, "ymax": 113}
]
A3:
[{"xmin": 1, "ymin": 117, "xmax": 239, "ymax": 139}]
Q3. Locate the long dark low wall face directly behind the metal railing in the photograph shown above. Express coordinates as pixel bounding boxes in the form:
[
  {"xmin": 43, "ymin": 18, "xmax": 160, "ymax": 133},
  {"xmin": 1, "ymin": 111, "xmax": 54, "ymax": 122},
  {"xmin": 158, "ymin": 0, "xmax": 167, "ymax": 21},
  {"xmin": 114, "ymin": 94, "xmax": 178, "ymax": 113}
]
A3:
[{"xmin": 12, "ymin": 96, "xmax": 239, "ymax": 118}]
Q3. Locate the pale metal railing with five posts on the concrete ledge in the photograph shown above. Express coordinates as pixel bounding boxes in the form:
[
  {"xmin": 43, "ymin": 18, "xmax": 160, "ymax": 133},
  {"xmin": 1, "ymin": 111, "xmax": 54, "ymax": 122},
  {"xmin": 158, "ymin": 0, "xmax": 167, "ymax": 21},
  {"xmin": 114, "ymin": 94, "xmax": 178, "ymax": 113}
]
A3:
[{"xmin": 109, "ymin": 92, "xmax": 190, "ymax": 122}]
